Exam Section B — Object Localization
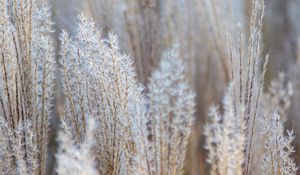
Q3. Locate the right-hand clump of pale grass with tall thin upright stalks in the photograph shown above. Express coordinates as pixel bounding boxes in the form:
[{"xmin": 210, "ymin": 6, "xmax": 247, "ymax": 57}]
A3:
[{"xmin": 205, "ymin": 0, "xmax": 296, "ymax": 175}]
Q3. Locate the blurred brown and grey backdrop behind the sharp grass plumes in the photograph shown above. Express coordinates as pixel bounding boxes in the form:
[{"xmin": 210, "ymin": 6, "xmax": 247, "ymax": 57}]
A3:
[{"xmin": 37, "ymin": 0, "xmax": 300, "ymax": 175}]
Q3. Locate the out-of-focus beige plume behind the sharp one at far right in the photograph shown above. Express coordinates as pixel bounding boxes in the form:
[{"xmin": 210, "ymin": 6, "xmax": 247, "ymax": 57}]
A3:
[{"xmin": 252, "ymin": 73, "xmax": 292, "ymax": 173}]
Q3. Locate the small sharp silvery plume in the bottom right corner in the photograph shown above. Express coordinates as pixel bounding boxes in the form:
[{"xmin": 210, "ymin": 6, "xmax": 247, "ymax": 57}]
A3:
[{"xmin": 262, "ymin": 112, "xmax": 297, "ymax": 175}]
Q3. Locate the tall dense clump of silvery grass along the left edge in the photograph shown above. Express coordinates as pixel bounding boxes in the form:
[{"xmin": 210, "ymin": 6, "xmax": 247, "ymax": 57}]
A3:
[{"xmin": 0, "ymin": 0, "xmax": 54, "ymax": 174}]
